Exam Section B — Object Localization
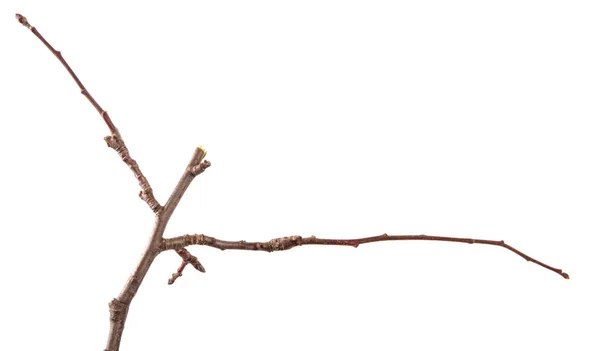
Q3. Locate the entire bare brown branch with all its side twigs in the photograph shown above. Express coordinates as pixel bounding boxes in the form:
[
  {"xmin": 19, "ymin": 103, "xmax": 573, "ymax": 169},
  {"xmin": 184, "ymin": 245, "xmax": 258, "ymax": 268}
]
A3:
[{"xmin": 16, "ymin": 14, "xmax": 569, "ymax": 351}]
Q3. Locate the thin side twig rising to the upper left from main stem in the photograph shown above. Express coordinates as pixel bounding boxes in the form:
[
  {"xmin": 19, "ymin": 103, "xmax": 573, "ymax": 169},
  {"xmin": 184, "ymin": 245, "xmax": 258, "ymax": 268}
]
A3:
[{"xmin": 15, "ymin": 13, "xmax": 162, "ymax": 213}]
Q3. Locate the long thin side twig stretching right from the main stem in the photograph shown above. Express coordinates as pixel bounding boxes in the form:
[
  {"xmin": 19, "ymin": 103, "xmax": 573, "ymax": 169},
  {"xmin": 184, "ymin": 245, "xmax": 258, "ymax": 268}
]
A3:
[{"xmin": 160, "ymin": 234, "xmax": 569, "ymax": 279}]
